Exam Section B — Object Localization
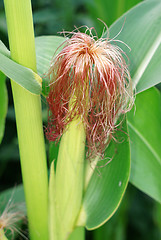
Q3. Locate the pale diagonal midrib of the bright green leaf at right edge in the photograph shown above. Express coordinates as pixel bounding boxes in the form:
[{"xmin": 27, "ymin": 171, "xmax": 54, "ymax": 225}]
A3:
[{"xmin": 127, "ymin": 121, "xmax": 161, "ymax": 165}]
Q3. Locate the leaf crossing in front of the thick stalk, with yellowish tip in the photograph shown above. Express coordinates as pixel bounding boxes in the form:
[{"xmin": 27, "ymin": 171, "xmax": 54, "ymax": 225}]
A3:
[{"xmin": 0, "ymin": 53, "xmax": 41, "ymax": 94}]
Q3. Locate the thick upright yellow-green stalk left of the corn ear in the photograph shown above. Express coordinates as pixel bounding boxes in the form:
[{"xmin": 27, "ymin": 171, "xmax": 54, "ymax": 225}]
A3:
[{"xmin": 4, "ymin": 0, "xmax": 48, "ymax": 240}]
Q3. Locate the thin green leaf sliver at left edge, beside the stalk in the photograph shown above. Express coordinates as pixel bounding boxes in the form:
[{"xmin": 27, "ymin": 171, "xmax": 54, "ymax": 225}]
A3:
[{"xmin": 0, "ymin": 72, "xmax": 8, "ymax": 143}]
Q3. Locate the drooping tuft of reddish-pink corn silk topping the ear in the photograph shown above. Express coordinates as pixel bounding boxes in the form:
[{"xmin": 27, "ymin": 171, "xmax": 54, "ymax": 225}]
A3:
[{"xmin": 46, "ymin": 29, "xmax": 133, "ymax": 158}]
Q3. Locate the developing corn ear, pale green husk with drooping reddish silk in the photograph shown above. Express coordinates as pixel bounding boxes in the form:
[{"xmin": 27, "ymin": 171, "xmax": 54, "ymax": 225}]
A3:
[{"xmin": 46, "ymin": 28, "xmax": 133, "ymax": 239}]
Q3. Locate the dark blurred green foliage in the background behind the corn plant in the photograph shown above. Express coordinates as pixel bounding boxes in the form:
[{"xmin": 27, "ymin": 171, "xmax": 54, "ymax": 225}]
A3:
[{"xmin": 0, "ymin": 0, "xmax": 161, "ymax": 240}]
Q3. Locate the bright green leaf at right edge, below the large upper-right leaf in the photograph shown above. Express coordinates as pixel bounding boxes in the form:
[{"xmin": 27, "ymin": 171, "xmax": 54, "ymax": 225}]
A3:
[{"xmin": 128, "ymin": 88, "xmax": 161, "ymax": 203}]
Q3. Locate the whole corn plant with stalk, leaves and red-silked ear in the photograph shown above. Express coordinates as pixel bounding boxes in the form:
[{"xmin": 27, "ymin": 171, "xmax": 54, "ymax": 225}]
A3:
[{"xmin": 0, "ymin": 0, "xmax": 161, "ymax": 240}]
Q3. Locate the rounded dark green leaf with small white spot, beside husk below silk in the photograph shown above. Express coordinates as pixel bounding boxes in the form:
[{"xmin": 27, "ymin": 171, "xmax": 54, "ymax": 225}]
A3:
[{"xmin": 78, "ymin": 121, "xmax": 130, "ymax": 230}]
